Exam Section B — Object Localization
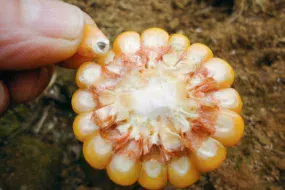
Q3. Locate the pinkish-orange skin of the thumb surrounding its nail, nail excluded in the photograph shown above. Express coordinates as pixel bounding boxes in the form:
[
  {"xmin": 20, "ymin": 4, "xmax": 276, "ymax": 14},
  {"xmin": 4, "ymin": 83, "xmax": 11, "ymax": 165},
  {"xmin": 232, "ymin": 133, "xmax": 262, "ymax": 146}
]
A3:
[{"xmin": 0, "ymin": 0, "xmax": 89, "ymax": 70}]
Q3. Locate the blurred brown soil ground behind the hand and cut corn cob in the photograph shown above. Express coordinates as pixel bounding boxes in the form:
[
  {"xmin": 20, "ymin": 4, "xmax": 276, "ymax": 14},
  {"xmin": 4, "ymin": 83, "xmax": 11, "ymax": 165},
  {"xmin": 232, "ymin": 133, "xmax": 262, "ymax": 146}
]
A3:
[{"xmin": 0, "ymin": 0, "xmax": 285, "ymax": 190}]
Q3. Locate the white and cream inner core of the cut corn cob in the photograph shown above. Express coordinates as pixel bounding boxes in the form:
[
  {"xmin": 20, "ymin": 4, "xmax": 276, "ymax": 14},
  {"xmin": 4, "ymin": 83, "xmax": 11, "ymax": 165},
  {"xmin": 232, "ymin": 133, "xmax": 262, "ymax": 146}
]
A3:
[{"xmin": 110, "ymin": 68, "xmax": 190, "ymax": 150}]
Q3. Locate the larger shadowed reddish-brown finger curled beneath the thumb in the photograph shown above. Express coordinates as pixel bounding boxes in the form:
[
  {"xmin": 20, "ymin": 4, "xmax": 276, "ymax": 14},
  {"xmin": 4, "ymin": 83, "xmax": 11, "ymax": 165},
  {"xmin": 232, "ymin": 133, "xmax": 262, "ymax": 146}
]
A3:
[{"xmin": 6, "ymin": 67, "xmax": 53, "ymax": 103}]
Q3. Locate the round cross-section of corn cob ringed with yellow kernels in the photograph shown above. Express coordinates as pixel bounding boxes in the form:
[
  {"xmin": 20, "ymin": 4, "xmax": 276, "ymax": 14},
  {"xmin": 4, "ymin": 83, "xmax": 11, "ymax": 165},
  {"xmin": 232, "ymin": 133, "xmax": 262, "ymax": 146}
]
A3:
[{"xmin": 72, "ymin": 24, "xmax": 244, "ymax": 189}]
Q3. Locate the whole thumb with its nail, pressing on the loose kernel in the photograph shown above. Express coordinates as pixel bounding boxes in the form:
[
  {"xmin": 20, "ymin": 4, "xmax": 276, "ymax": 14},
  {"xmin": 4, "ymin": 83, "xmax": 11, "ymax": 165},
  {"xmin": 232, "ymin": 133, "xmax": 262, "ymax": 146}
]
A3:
[{"xmin": 0, "ymin": 0, "xmax": 90, "ymax": 70}]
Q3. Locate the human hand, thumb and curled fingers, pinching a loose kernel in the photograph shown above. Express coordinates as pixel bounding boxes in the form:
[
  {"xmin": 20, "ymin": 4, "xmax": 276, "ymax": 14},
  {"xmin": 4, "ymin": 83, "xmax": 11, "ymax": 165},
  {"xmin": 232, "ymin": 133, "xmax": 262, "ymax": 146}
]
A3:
[{"xmin": 0, "ymin": 0, "xmax": 100, "ymax": 113}]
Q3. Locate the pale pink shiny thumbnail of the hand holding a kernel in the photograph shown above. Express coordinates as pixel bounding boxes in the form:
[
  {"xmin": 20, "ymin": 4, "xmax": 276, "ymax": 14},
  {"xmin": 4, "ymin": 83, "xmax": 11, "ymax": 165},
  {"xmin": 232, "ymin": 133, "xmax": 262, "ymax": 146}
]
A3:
[{"xmin": 20, "ymin": 0, "xmax": 84, "ymax": 40}]
